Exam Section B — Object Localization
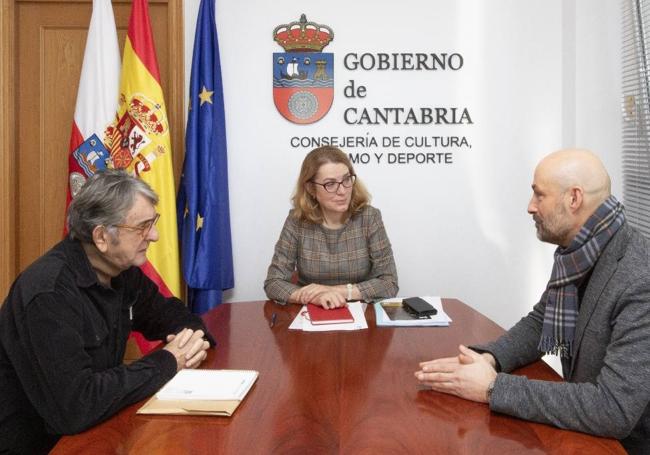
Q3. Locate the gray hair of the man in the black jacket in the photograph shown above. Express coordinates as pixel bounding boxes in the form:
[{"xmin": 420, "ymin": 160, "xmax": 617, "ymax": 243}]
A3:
[{"xmin": 67, "ymin": 169, "xmax": 158, "ymax": 243}]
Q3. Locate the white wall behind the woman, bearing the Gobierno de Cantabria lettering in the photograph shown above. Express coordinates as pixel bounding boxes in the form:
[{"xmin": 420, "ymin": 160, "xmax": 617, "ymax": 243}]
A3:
[{"xmin": 185, "ymin": 0, "xmax": 621, "ymax": 338}]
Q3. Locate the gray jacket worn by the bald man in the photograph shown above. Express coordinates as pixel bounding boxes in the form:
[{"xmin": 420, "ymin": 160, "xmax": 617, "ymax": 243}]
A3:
[{"xmin": 477, "ymin": 223, "xmax": 650, "ymax": 453}]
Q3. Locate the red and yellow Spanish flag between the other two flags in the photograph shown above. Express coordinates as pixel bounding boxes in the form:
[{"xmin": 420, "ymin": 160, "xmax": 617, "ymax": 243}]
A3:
[{"xmin": 106, "ymin": 0, "xmax": 181, "ymax": 297}]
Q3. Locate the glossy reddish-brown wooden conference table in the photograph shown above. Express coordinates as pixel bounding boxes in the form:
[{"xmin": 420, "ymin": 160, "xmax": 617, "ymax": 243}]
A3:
[{"xmin": 53, "ymin": 299, "xmax": 625, "ymax": 455}]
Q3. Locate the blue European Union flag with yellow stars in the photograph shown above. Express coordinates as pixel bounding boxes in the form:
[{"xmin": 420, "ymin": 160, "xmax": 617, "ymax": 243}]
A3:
[{"xmin": 177, "ymin": 0, "xmax": 234, "ymax": 313}]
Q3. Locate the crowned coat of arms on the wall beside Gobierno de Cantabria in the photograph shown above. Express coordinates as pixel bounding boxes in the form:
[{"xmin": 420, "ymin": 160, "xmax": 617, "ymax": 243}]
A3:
[{"xmin": 273, "ymin": 14, "xmax": 334, "ymax": 124}]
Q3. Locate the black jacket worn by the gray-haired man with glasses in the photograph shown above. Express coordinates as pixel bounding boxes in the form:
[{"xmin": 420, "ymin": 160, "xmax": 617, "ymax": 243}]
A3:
[{"xmin": 0, "ymin": 239, "xmax": 214, "ymax": 452}]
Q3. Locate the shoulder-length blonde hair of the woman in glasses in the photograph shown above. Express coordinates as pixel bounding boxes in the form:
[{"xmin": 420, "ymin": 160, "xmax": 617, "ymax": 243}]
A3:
[{"xmin": 291, "ymin": 145, "xmax": 370, "ymax": 224}]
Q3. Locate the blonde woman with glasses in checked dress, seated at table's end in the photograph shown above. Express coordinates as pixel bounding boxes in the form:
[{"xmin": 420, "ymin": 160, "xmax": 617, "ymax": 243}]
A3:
[{"xmin": 264, "ymin": 146, "xmax": 398, "ymax": 308}]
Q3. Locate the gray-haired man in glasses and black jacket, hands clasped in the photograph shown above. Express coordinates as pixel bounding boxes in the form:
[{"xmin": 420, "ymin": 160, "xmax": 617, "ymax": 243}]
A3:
[{"xmin": 0, "ymin": 170, "xmax": 214, "ymax": 453}]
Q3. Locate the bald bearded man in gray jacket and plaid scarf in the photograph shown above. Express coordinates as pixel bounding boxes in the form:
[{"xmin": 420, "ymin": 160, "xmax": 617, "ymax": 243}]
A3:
[{"xmin": 415, "ymin": 150, "xmax": 650, "ymax": 454}]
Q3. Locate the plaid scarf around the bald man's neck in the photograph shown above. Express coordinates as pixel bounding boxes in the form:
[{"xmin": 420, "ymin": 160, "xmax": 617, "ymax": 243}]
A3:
[{"xmin": 538, "ymin": 196, "xmax": 625, "ymax": 358}]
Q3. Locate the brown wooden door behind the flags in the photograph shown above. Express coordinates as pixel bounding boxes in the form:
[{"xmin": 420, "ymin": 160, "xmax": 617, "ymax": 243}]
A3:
[{"xmin": 0, "ymin": 0, "xmax": 184, "ymax": 299}]
